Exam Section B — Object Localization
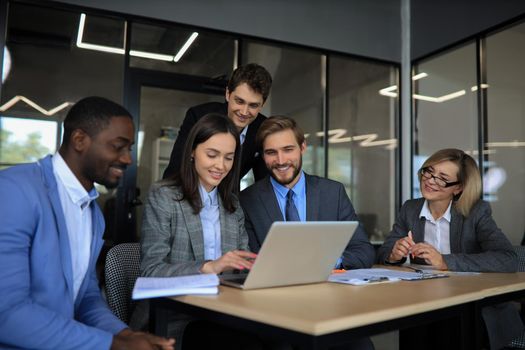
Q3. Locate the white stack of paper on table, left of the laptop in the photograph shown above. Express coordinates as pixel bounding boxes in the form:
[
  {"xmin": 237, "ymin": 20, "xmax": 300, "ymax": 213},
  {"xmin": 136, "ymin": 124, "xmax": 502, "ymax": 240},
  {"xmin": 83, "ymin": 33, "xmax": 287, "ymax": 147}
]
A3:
[{"xmin": 132, "ymin": 274, "xmax": 219, "ymax": 299}]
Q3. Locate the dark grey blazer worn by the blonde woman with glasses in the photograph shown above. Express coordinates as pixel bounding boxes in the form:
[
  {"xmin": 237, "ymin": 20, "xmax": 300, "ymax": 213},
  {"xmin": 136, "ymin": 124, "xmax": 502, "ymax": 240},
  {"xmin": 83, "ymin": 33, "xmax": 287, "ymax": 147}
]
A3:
[{"xmin": 378, "ymin": 198, "xmax": 518, "ymax": 272}]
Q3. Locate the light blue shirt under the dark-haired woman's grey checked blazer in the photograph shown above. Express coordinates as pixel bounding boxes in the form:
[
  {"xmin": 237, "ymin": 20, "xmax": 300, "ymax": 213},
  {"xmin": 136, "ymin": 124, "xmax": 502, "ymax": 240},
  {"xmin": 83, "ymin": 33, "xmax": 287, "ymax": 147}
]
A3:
[{"xmin": 199, "ymin": 185, "xmax": 222, "ymax": 260}]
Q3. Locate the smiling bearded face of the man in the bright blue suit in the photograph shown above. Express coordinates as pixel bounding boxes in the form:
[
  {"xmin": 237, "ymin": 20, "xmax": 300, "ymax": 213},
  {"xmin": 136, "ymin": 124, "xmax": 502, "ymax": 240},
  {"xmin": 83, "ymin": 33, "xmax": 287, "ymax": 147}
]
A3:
[{"xmin": 77, "ymin": 117, "xmax": 135, "ymax": 190}]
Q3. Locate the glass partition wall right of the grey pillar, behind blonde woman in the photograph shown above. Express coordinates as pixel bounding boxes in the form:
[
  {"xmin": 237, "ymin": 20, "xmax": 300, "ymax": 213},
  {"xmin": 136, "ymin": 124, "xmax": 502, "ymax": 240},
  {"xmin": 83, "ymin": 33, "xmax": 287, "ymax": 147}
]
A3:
[{"xmin": 412, "ymin": 20, "xmax": 525, "ymax": 244}]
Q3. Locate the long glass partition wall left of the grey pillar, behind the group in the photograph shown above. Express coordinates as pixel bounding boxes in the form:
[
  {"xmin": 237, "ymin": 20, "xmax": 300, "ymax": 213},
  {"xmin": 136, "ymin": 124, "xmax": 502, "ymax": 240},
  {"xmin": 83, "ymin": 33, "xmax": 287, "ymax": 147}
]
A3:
[{"xmin": 0, "ymin": 1, "xmax": 399, "ymax": 243}]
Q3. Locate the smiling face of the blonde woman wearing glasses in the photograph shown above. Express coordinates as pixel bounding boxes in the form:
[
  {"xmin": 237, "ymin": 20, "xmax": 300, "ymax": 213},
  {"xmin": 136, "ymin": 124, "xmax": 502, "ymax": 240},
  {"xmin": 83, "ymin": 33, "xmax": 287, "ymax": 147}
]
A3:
[{"xmin": 420, "ymin": 160, "xmax": 461, "ymax": 202}]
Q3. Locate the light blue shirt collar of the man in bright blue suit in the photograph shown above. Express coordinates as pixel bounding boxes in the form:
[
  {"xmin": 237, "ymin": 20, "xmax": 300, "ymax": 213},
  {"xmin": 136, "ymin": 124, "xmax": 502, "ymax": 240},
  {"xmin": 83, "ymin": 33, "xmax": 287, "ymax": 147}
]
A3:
[{"xmin": 52, "ymin": 152, "xmax": 98, "ymax": 209}]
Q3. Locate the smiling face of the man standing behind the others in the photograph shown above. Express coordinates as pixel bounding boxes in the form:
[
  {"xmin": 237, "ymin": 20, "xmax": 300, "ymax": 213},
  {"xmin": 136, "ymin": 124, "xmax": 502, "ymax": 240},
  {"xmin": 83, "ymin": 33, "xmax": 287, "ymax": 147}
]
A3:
[{"xmin": 226, "ymin": 83, "xmax": 264, "ymax": 131}]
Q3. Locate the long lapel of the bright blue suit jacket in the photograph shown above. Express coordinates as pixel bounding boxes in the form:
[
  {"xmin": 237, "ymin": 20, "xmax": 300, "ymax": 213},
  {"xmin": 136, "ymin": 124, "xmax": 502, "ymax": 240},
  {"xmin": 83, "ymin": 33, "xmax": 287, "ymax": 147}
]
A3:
[{"xmin": 40, "ymin": 156, "xmax": 74, "ymax": 300}]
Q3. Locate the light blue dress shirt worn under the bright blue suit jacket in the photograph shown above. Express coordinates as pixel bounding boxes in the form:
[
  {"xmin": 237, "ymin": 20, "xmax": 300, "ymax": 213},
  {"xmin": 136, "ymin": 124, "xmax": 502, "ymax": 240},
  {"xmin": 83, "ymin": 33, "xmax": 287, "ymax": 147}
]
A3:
[{"xmin": 52, "ymin": 152, "xmax": 98, "ymax": 299}]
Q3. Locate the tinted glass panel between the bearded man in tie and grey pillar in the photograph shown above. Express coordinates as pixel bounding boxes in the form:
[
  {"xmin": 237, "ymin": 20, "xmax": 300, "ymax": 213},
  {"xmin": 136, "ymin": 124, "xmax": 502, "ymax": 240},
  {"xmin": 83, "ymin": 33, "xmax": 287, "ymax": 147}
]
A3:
[{"xmin": 328, "ymin": 57, "xmax": 398, "ymax": 241}]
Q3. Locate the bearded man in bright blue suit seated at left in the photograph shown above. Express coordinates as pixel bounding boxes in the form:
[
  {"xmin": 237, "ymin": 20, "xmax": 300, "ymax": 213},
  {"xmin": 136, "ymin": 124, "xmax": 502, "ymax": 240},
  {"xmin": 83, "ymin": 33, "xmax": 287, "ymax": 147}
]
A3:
[{"xmin": 0, "ymin": 97, "xmax": 174, "ymax": 349}]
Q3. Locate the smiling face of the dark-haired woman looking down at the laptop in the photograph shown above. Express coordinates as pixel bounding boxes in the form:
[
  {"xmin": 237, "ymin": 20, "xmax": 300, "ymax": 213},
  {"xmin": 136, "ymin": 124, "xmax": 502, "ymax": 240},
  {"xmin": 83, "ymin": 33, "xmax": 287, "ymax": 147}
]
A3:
[{"xmin": 192, "ymin": 133, "xmax": 236, "ymax": 192}]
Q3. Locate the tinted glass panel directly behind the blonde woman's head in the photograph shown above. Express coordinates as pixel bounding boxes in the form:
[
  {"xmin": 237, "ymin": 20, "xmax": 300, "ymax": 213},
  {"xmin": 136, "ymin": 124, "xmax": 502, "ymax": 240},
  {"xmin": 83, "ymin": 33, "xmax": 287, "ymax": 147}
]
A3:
[{"xmin": 412, "ymin": 44, "xmax": 478, "ymax": 197}]
